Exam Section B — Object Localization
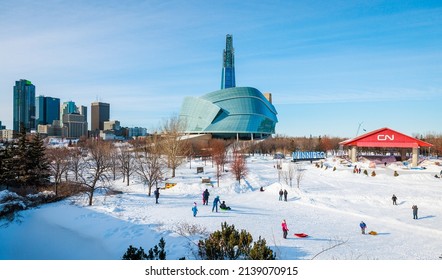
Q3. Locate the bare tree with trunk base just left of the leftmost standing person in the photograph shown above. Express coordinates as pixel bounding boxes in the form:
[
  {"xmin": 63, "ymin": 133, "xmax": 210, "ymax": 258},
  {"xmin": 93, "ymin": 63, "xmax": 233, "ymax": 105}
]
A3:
[{"xmin": 134, "ymin": 135, "xmax": 166, "ymax": 196}]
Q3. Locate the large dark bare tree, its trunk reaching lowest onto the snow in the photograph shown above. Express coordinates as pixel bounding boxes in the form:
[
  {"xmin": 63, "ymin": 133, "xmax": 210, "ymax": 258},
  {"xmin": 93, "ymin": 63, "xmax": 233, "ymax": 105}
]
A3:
[{"xmin": 79, "ymin": 140, "xmax": 112, "ymax": 206}]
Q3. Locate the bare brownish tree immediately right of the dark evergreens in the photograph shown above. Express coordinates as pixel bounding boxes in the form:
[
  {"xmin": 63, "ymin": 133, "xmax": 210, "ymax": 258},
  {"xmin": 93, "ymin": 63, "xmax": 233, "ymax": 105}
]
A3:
[{"xmin": 46, "ymin": 147, "xmax": 70, "ymax": 196}]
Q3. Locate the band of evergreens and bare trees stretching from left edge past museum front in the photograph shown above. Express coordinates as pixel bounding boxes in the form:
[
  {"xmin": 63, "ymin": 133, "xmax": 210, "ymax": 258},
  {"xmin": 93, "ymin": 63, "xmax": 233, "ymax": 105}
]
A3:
[{"xmin": 0, "ymin": 118, "xmax": 246, "ymax": 205}]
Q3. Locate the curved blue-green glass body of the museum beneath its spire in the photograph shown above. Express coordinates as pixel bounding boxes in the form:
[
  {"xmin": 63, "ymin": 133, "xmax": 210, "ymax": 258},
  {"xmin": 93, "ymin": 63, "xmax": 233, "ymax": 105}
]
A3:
[{"xmin": 180, "ymin": 87, "xmax": 278, "ymax": 139}]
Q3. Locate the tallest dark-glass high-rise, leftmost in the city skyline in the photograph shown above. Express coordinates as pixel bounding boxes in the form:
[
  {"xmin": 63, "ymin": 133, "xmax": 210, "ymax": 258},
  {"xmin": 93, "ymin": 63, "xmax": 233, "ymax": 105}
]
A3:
[{"xmin": 13, "ymin": 79, "xmax": 35, "ymax": 132}]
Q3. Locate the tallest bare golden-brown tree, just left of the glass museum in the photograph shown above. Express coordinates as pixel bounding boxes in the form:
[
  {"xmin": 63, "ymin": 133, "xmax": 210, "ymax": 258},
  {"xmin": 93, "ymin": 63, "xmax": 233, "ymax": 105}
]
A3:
[{"xmin": 160, "ymin": 117, "xmax": 190, "ymax": 178}]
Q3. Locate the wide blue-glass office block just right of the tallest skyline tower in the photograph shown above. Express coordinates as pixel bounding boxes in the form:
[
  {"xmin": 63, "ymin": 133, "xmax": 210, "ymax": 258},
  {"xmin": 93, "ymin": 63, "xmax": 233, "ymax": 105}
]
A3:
[{"xmin": 35, "ymin": 95, "xmax": 60, "ymax": 127}]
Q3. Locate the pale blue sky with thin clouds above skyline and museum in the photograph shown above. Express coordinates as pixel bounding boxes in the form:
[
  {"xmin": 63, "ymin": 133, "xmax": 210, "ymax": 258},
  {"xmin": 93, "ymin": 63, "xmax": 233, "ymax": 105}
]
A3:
[{"xmin": 0, "ymin": 0, "xmax": 442, "ymax": 137}]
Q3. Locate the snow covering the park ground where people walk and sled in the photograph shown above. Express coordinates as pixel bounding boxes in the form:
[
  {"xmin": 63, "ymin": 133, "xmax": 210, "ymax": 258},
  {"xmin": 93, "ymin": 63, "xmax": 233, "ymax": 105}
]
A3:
[{"xmin": 0, "ymin": 156, "xmax": 442, "ymax": 260}]
